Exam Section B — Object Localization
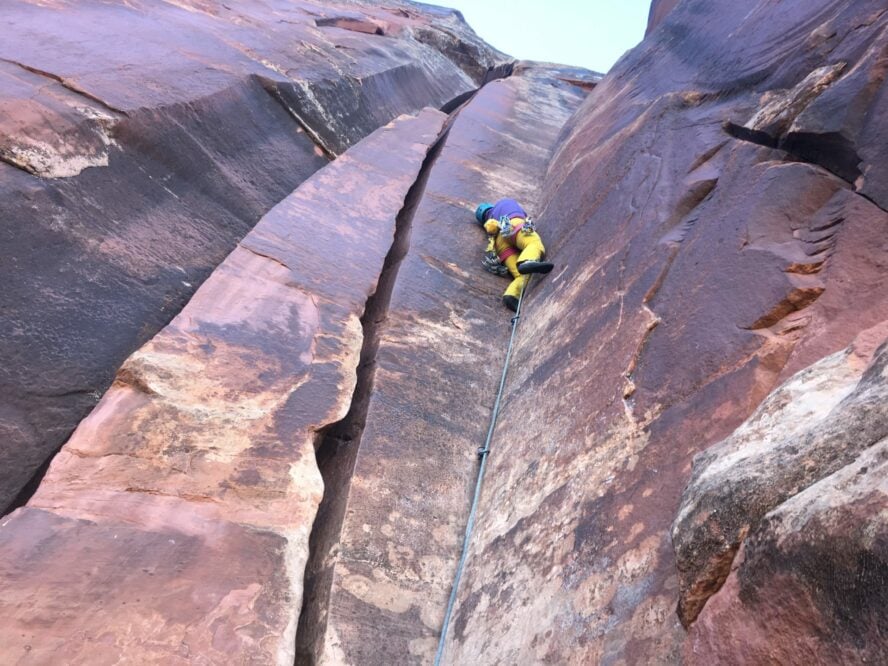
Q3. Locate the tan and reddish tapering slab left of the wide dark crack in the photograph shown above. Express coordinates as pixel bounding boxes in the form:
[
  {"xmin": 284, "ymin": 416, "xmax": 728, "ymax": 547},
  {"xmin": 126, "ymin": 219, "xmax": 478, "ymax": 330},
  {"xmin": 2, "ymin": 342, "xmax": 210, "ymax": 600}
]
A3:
[{"xmin": 0, "ymin": 110, "xmax": 446, "ymax": 664}]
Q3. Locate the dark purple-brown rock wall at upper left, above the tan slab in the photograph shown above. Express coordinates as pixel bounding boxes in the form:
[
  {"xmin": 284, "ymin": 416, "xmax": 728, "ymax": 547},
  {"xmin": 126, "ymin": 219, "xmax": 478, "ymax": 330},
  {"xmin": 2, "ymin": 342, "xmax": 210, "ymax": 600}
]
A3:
[{"xmin": 0, "ymin": 0, "xmax": 504, "ymax": 510}]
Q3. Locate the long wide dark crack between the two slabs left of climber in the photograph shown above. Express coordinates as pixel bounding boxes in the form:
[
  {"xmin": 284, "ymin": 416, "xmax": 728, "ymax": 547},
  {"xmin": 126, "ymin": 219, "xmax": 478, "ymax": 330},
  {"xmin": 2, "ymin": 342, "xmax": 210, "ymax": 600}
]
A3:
[{"xmin": 295, "ymin": 126, "xmax": 455, "ymax": 665}]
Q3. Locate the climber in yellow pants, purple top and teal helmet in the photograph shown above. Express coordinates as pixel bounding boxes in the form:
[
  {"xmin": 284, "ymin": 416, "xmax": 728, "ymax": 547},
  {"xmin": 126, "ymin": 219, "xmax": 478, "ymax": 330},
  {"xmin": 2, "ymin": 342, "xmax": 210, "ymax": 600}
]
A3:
[{"xmin": 475, "ymin": 199, "xmax": 555, "ymax": 312}]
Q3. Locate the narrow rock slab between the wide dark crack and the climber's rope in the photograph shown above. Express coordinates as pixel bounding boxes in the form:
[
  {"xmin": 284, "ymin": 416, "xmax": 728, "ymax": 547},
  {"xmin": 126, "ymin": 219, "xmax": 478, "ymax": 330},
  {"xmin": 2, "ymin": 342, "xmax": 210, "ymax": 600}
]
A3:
[{"xmin": 300, "ymin": 63, "xmax": 594, "ymax": 665}]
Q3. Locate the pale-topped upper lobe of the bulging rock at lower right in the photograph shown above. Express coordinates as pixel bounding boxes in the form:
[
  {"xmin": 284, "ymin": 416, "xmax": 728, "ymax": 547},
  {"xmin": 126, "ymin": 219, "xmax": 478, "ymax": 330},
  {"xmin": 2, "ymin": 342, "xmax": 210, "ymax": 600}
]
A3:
[{"xmin": 672, "ymin": 326, "xmax": 888, "ymax": 625}]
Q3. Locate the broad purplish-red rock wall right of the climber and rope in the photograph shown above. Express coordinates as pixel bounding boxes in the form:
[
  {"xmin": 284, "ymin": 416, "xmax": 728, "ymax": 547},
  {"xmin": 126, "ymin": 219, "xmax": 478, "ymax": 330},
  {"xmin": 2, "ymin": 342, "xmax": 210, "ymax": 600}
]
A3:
[{"xmin": 448, "ymin": 0, "xmax": 888, "ymax": 664}]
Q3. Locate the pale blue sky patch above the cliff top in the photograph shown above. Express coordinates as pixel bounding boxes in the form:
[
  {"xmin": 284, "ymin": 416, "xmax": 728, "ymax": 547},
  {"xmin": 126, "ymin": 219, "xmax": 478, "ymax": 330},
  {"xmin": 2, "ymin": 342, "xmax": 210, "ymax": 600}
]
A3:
[{"xmin": 438, "ymin": 0, "xmax": 651, "ymax": 72}]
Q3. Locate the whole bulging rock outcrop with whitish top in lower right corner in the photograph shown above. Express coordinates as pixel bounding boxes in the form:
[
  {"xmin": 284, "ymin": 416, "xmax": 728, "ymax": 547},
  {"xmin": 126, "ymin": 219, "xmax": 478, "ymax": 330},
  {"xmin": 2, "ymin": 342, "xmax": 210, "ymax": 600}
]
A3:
[{"xmin": 673, "ymin": 326, "xmax": 888, "ymax": 664}]
